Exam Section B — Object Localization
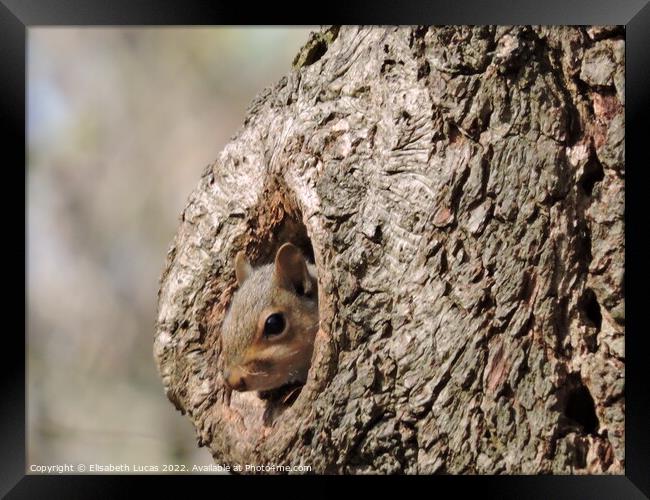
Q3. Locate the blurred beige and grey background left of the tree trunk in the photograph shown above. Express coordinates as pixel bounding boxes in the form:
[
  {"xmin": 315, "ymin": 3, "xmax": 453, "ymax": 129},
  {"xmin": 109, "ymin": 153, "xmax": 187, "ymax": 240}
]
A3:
[{"xmin": 27, "ymin": 27, "xmax": 315, "ymax": 466}]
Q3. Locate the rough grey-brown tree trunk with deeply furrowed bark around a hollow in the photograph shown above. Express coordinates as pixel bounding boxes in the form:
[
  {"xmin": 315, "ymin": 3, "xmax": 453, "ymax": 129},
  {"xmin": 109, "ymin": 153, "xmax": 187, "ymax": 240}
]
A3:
[{"xmin": 155, "ymin": 26, "xmax": 625, "ymax": 473}]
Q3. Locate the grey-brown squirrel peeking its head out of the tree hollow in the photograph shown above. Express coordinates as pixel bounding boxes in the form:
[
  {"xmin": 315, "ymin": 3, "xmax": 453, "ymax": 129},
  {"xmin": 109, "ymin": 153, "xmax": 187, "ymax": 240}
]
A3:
[{"xmin": 221, "ymin": 243, "xmax": 319, "ymax": 393}]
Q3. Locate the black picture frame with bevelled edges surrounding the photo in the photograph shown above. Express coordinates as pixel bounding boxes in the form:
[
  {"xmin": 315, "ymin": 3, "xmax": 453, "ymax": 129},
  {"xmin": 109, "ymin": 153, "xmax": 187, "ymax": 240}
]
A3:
[{"xmin": 6, "ymin": 0, "xmax": 650, "ymax": 499}]
